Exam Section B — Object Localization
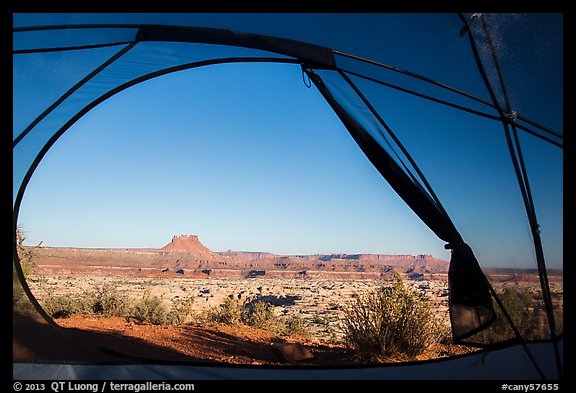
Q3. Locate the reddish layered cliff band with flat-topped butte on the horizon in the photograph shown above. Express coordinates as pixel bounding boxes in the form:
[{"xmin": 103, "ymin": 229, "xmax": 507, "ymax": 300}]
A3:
[{"xmin": 25, "ymin": 235, "xmax": 448, "ymax": 280}]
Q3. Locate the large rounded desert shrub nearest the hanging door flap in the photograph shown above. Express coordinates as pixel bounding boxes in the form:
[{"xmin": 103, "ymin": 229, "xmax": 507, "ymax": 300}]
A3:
[{"xmin": 342, "ymin": 275, "xmax": 439, "ymax": 359}]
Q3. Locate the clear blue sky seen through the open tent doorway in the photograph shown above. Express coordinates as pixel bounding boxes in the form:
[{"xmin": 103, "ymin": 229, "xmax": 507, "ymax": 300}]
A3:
[{"xmin": 19, "ymin": 64, "xmax": 449, "ymax": 258}]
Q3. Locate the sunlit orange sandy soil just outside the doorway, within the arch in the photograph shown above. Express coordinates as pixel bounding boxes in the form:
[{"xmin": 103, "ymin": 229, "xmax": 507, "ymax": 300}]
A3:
[{"xmin": 48, "ymin": 316, "xmax": 469, "ymax": 366}]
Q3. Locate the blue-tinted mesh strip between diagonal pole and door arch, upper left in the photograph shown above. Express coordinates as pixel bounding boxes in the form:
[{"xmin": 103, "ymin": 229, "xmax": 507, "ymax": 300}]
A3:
[{"xmin": 13, "ymin": 42, "xmax": 296, "ymax": 202}]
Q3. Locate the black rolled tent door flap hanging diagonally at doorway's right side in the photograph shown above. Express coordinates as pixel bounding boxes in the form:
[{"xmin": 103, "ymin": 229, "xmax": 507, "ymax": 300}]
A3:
[{"xmin": 309, "ymin": 69, "xmax": 496, "ymax": 342}]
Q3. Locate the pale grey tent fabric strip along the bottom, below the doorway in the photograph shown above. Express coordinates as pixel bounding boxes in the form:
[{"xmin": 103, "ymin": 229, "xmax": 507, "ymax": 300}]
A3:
[{"xmin": 12, "ymin": 343, "xmax": 556, "ymax": 381}]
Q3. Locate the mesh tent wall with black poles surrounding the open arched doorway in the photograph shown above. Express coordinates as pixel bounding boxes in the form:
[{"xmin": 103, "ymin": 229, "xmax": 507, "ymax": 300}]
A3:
[{"xmin": 13, "ymin": 13, "xmax": 563, "ymax": 379}]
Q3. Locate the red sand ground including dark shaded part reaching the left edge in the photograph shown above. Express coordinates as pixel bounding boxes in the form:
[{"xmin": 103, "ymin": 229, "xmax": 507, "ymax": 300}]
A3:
[{"xmin": 13, "ymin": 316, "xmax": 468, "ymax": 366}]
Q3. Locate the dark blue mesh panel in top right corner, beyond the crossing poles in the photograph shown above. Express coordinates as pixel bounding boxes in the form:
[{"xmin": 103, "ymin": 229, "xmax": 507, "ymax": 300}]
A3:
[{"xmin": 464, "ymin": 13, "xmax": 563, "ymax": 134}]
